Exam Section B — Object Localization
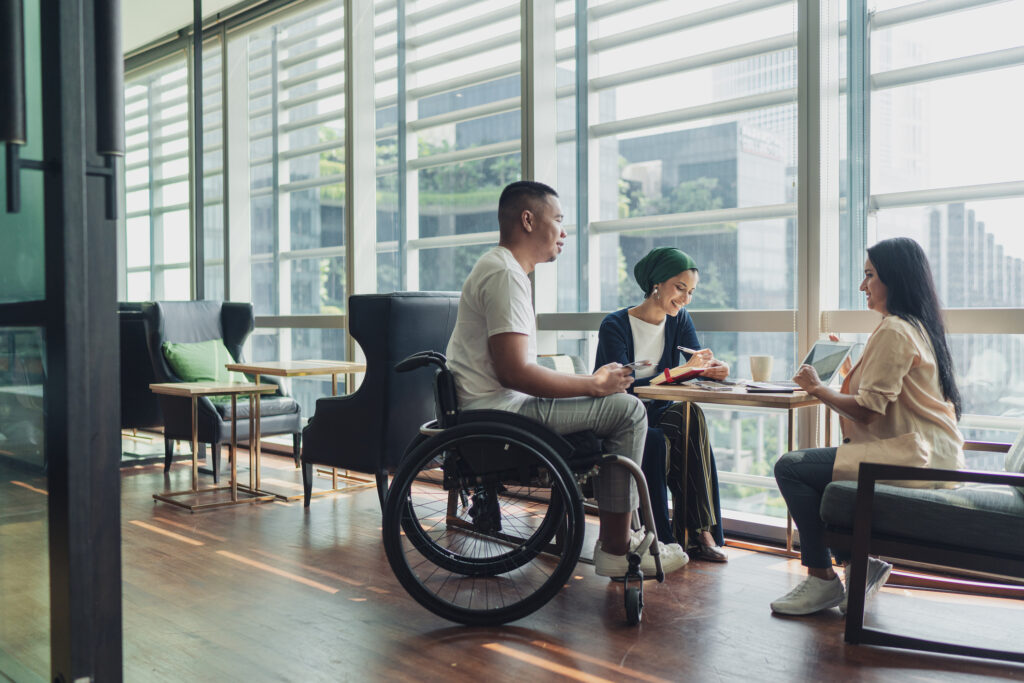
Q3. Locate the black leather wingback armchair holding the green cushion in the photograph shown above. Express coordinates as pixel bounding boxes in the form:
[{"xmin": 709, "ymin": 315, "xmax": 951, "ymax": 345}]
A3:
[{"xmin": 142, "ymin": 301, "xmax": 302, "ymax": 481}]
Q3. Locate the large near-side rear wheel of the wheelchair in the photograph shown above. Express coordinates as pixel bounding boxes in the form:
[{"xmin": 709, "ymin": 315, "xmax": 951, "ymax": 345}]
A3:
[{"xmin": 383, "ymin": 423, "xmax": 584, "ymax": 625}]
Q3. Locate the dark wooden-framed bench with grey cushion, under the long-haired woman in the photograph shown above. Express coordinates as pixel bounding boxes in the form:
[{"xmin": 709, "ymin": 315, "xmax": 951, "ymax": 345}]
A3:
[{"xmin": 821, "ymin": 444, "xmax": 1024, "ymax": 663}]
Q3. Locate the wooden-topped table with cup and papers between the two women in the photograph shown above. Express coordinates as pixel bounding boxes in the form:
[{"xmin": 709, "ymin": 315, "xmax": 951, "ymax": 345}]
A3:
[{"xmin": 635, "ymin": 384, "xmax": 831, "ymax": 552}]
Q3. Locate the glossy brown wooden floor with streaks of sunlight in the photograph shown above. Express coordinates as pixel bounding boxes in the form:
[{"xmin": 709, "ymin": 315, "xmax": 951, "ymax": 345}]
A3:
[{"xmin": 0, "ymin": 446, "xmax": 1024, "ymax": 683}]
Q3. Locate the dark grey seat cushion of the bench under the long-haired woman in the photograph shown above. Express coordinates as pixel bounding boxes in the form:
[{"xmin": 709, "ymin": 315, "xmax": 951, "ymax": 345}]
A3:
[{"xmin": 821, "ymin": 481, "xmax": 1024, "ymax": 557}]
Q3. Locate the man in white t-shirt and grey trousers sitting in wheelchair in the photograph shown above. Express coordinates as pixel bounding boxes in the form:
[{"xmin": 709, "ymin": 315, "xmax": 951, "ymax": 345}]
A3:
[{"xmin": 446, "ymin": 180, "xmax": 688, "ymax": 578}]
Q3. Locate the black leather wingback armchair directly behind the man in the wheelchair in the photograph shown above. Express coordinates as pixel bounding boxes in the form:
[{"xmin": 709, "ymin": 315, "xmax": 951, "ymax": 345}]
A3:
[{"xmin": 302, "ymin": 292, "xmax": 459, "ymax": 506}]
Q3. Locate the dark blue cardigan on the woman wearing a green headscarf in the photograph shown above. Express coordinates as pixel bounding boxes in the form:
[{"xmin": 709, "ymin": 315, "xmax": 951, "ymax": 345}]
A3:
[{"xmin": 594, "ymin": 308, "xmax": 700, "ymax": 426}]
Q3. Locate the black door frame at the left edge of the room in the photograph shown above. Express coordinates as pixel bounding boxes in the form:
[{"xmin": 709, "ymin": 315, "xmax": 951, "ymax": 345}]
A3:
[{"xmin": 0, "ymin": 0, "xmax": 123, "ymax": 683}]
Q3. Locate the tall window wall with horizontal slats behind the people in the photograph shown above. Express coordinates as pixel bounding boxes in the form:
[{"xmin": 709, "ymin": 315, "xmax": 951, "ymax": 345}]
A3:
[{"xmin": 126, "ymin": 0, "xmax": 1024, "ymax": 540}]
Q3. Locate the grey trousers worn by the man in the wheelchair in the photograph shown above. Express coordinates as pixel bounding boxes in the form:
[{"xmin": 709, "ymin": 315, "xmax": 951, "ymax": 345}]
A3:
[{"xmin": 515, "ymin": 393, "xmax": 647, "ymax": 512}]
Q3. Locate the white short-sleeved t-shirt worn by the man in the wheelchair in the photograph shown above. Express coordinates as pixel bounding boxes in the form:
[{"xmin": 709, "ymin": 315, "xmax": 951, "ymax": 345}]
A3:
[{"xmin": 446, "ymin": 247, "xmax": 537, "ymax": 411}]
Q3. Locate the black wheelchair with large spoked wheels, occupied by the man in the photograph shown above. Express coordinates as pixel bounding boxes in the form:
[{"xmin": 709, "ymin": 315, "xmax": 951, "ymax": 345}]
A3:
[{"xmin": 383, "ymin": 351, "xmax": 665, "ymax": 626}]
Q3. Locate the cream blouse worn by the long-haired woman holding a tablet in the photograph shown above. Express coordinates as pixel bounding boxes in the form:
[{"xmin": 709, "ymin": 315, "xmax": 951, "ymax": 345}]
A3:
[{"xmin": 840, "ymin": 315, "xmax": 965, "ymax": 469}]
